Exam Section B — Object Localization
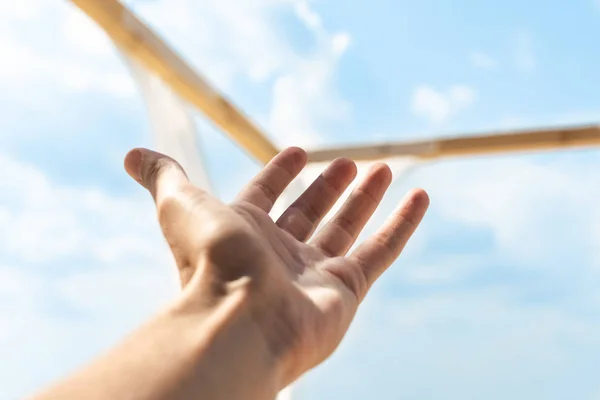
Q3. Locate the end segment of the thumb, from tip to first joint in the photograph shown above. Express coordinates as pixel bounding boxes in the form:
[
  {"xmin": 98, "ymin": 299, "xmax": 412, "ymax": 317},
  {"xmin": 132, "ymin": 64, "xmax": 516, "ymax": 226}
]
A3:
[{"xmin": 125, "ymin": 148, "xmax": 189, "ymax": 205}]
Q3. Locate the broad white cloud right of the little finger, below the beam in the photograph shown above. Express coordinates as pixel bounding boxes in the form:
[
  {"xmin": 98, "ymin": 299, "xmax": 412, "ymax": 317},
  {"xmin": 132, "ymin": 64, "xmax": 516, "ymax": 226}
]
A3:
[{"xmin": 417, "ymin": 154, "xmax": 600, "ymax": 268}]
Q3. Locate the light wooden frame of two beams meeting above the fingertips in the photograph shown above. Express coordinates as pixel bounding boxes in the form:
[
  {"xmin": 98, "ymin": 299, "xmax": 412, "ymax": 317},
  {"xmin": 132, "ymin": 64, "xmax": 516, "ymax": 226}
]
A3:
[{"xmin": 71, "ymin": 0, "xmax": 600, "ymax": 164}]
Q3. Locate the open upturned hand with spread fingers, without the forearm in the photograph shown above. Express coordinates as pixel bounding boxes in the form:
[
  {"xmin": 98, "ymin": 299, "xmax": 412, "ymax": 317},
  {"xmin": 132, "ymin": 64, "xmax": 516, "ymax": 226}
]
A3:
[{"xmin": 125, "ymin": 148, "xmax": 429, "ymax": 388}]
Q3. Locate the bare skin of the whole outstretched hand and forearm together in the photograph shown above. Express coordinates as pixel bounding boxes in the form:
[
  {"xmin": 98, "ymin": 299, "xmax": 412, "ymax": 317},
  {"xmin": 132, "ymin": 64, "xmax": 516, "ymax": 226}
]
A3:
[{"xmin": 36, "ymin": 148, "xmax": 429, "ymax": 400}]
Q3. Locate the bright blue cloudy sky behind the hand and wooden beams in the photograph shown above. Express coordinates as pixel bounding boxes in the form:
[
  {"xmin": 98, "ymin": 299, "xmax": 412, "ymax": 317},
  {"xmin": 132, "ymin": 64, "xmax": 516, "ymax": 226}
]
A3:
[{"xmin": 0, "ymin": 0, "xmax": 600, "ymax": 400}]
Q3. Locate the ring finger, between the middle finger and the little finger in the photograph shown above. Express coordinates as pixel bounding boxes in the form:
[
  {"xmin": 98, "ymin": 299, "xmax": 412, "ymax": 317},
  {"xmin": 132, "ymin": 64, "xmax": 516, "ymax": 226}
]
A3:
[{"xmin": 312, "ymin": 164, "xmax": 392, "ymax": 257}]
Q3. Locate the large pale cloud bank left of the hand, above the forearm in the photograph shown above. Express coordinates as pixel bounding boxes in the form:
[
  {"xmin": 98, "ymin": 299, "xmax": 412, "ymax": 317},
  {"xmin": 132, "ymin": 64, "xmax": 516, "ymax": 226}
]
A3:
[{"xmin": 0, "ymin": 151, "xmax": 178, "ymax": 398}]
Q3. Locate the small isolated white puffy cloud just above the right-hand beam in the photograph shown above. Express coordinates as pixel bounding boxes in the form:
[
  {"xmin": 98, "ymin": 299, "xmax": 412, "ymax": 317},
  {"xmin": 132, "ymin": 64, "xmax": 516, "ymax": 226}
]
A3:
[{"xmin": 411, "ymin": 85, "xmax": 477, "ymax": 123}]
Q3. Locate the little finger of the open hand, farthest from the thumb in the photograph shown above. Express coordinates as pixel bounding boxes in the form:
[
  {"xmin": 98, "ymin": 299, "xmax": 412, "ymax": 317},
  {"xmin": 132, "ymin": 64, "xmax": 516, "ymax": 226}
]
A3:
[{"xmin": 350, "ymin": 189, "xmax": 429, "ymax": 288}]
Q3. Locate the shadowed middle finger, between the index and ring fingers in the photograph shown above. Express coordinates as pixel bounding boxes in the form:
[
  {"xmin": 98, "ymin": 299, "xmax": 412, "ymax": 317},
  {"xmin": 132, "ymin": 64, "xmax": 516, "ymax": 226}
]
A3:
[{"xmin": 277, "ymin": 158, "xmax": 356, "ymax": 242}]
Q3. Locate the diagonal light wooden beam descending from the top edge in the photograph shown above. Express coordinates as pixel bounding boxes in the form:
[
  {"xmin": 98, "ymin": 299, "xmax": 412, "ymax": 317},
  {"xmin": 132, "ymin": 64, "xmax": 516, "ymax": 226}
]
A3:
[{"xmin": 71, "ymin": 0, "xmax": 278, "ymax": 164}]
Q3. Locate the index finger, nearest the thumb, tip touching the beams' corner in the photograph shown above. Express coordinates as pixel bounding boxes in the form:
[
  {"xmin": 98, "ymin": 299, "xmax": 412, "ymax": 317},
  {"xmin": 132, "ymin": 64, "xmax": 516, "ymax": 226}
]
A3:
[{"xmin": 236, "ymin": 147, "xmax": 306, "ymax": 212}]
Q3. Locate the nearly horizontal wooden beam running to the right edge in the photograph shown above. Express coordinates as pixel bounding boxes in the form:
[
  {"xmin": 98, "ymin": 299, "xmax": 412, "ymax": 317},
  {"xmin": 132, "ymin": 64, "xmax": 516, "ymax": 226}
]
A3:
[{"xmin": 308, "ymin": 126, "xmax": 600, "ymax": 162}]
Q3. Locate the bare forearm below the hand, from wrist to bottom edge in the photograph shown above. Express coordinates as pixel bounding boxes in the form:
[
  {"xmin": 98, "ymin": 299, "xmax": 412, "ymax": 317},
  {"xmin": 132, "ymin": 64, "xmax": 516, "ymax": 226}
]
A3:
[{"xmin": 35, "ymin": 290, "xmax": 280, "ymax": 400}]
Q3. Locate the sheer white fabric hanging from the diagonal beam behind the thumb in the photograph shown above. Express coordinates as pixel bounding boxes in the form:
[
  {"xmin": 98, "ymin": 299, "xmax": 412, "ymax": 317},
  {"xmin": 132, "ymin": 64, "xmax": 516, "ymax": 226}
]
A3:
[{"xmin": 121, "ymin": 52, "xmax": 211, "ymax": 192}]
